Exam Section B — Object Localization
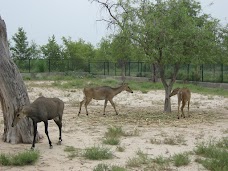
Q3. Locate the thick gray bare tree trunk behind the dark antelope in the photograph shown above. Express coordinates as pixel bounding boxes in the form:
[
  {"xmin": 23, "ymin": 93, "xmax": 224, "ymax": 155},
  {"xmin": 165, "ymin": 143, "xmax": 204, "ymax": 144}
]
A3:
[{"xmin": 0, "ymin": 16, "xmax": 33, "ymax": 143}]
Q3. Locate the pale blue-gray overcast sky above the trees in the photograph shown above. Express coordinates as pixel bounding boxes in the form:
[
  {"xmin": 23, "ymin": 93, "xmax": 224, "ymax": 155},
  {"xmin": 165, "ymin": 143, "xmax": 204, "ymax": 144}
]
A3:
[{"xmin": 0, "ymin": 0, "xmax": 228, "ymax": 46}]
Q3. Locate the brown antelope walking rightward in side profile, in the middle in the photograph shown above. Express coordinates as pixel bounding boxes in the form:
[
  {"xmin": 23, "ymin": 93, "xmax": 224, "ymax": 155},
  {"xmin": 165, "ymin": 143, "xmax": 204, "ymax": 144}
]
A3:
[{"xmin": 78, "ymin": 83, "xmax": 133, "ymax": 116}]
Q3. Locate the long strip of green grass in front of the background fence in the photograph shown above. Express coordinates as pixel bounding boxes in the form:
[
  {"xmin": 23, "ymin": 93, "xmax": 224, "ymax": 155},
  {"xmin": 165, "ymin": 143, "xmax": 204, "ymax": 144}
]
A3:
[{"xmin": 24, "ymin": 75, "xmax": 228, "ymax": 98}]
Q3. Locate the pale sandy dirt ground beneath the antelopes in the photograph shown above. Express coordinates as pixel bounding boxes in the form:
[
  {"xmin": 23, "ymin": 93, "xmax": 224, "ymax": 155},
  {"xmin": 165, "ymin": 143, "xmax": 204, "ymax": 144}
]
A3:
[{"xmin": 0, "ymin": 81, "xmax": 228, "ymax": 171}]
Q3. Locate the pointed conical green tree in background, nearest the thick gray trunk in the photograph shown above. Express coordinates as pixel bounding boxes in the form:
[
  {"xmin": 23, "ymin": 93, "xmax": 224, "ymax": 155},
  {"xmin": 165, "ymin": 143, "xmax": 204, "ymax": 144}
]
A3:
[{"xmin": 10, "ymin": 27, "xmax": 32, "ymax": 59}]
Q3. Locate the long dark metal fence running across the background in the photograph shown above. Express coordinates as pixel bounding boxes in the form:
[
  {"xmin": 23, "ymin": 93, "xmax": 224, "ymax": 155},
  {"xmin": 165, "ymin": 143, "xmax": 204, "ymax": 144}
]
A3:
[{"xmin": 15, "ymin": 59, "xmax": 228, "ymax": 83}]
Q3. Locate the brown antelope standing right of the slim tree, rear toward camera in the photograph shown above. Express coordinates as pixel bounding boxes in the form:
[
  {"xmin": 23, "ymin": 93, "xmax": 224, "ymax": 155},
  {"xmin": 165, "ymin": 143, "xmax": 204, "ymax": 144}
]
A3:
[{"xmin": 169, "ymin": 88, "xmax": 191, "ymax": 119}]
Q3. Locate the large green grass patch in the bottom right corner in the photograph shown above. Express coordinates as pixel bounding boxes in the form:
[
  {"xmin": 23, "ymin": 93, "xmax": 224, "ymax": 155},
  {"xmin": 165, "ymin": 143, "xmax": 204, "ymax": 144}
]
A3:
[{"xmin": 195, "ymin": 139, "xmax": 228, "ymax": 171}]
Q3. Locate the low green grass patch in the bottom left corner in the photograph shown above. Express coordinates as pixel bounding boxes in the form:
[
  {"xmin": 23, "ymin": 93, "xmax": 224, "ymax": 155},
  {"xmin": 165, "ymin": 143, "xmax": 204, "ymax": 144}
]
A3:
[{"xmin": 0, "ymin": 150, "xmax": 40, "ymax": 166}]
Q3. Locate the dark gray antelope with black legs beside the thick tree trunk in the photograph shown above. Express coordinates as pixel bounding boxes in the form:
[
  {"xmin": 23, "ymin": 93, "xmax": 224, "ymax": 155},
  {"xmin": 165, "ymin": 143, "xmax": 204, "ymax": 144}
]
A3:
[{"xmin": 12, "ymin": 97, "xmax": 64, "ymax": 149}]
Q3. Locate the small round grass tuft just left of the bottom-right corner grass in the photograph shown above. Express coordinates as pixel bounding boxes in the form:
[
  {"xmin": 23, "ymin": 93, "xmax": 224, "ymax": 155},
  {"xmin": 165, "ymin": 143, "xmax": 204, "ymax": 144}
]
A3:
[{"xmin": 172, "ymin": 153, "xmax": 190, "ymax": 167}]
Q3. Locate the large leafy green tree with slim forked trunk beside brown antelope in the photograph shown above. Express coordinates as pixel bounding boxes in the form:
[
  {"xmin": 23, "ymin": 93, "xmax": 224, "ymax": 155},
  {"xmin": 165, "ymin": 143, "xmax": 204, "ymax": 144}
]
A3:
[{"xmin": 93, "ymin": 0, "xmax": 223, "ymax": 112}]
